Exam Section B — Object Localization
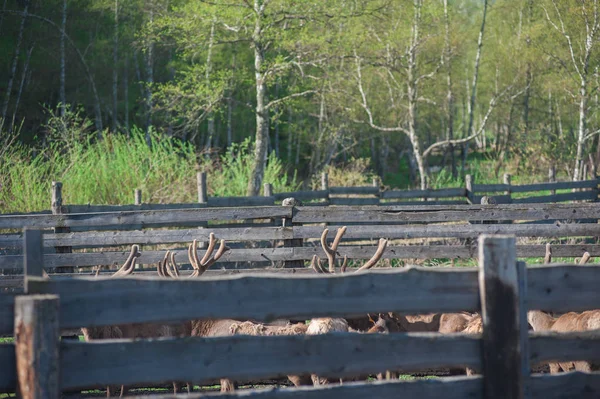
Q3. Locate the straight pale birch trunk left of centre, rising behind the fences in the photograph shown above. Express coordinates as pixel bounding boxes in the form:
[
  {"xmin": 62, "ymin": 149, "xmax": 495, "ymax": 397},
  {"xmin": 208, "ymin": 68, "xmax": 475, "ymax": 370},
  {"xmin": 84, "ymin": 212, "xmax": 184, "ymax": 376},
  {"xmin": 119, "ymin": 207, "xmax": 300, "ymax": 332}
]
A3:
[{"xmin": 247, "ymin": 0, "xmax": 269, "ymax": 196}]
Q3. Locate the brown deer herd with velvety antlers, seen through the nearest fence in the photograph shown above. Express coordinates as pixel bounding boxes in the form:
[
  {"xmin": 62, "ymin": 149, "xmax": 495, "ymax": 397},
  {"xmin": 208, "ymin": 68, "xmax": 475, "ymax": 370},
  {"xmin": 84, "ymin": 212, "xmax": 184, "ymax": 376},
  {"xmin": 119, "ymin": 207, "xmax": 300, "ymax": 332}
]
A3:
[{"xmin": 77, "ymin": 227, "xmax": 600, "ymax": 396}]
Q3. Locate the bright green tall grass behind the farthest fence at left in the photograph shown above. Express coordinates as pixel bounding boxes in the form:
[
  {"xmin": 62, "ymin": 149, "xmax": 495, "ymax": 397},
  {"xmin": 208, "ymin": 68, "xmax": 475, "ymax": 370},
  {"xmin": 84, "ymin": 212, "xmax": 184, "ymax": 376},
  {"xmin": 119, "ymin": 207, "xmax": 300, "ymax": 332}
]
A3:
[{"xmin": 0, "ymin": 129, "xmax": 297, "ymax": 213}]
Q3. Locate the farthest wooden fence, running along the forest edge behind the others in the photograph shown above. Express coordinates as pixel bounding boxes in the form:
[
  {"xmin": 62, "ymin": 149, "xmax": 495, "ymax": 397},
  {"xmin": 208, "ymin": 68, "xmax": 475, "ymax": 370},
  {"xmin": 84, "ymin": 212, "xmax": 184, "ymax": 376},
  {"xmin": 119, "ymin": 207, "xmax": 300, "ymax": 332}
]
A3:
[{"xmin": 5, "ymin": 172, "xmax": 598, "ymax": 214}]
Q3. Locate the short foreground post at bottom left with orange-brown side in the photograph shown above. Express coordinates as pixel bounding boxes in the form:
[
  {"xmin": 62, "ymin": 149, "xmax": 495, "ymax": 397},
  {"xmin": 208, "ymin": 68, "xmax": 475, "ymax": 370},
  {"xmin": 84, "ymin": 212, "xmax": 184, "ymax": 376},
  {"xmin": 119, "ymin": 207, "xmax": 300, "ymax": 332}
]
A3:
[{"xmin": 15, "ymin": 295, "xmax": 60, "ymax": 399}]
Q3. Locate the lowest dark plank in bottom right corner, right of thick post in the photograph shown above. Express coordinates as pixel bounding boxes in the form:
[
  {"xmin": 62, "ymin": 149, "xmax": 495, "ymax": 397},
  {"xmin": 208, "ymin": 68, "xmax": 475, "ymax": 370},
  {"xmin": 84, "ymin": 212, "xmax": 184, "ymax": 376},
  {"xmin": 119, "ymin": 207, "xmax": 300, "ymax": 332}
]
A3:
[{"xmin": 531, "ymin": 372, "xmax": 600, "ymax": 399}]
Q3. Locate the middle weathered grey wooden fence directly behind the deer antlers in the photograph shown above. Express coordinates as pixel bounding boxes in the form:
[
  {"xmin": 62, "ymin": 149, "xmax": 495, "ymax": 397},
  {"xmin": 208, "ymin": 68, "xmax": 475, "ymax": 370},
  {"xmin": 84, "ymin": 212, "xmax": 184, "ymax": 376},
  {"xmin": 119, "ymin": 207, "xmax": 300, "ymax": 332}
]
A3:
[{"xmin": 0, "ymin": 203, "xmax": 600, "ymax": 282}]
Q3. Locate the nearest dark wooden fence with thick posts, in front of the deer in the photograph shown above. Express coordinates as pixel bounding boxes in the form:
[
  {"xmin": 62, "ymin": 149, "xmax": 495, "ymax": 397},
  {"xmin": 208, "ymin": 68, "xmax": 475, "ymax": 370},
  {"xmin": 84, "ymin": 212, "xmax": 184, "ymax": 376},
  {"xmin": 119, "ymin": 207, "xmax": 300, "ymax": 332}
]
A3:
[{"xmin": 0, "ymin": 231, "xmax": 600, "ymax": 399}]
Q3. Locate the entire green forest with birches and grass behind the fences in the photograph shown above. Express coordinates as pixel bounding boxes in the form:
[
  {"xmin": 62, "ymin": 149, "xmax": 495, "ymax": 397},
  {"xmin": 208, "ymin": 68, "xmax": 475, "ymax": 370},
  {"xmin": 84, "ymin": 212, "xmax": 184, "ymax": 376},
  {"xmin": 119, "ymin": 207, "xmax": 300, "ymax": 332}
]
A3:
[{"xmin": 0, "ymin": 0, "xmax": 600, "ymax": 212}]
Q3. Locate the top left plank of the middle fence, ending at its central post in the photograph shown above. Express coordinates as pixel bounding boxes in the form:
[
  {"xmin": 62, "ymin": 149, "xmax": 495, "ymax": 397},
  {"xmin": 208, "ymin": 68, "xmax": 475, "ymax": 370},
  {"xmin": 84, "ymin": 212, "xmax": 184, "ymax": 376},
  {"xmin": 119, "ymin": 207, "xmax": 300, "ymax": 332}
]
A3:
[{"xmin": 0, "ymin": 206, "xmax": 292, "ymax": 229}]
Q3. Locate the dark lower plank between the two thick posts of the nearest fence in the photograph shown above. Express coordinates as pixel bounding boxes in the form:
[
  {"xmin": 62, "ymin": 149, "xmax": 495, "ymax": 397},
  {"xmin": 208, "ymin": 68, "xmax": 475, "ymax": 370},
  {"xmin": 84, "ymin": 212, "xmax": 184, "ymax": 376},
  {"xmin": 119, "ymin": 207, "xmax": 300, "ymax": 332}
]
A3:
[{"xmin": 60, "ymin": 333, "xmax": 480, "ymax": 389}]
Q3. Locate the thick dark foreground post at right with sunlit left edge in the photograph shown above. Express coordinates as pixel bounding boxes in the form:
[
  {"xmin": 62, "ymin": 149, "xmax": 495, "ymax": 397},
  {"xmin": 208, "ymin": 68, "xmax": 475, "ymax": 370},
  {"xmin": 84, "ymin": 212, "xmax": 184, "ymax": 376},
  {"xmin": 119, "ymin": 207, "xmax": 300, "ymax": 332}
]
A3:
[{"xmin": 479, "ymin": 234, "xmax": 529, "ymax": 399}]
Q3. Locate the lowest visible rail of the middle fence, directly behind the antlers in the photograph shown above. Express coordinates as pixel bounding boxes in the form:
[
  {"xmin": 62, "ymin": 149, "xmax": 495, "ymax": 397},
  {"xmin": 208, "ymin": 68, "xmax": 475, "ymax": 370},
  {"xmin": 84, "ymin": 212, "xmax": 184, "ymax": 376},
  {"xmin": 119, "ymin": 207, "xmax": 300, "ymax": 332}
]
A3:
[{"xmin": 0, "ymin": 244, "xmax": 600, "ymax": 270}]
